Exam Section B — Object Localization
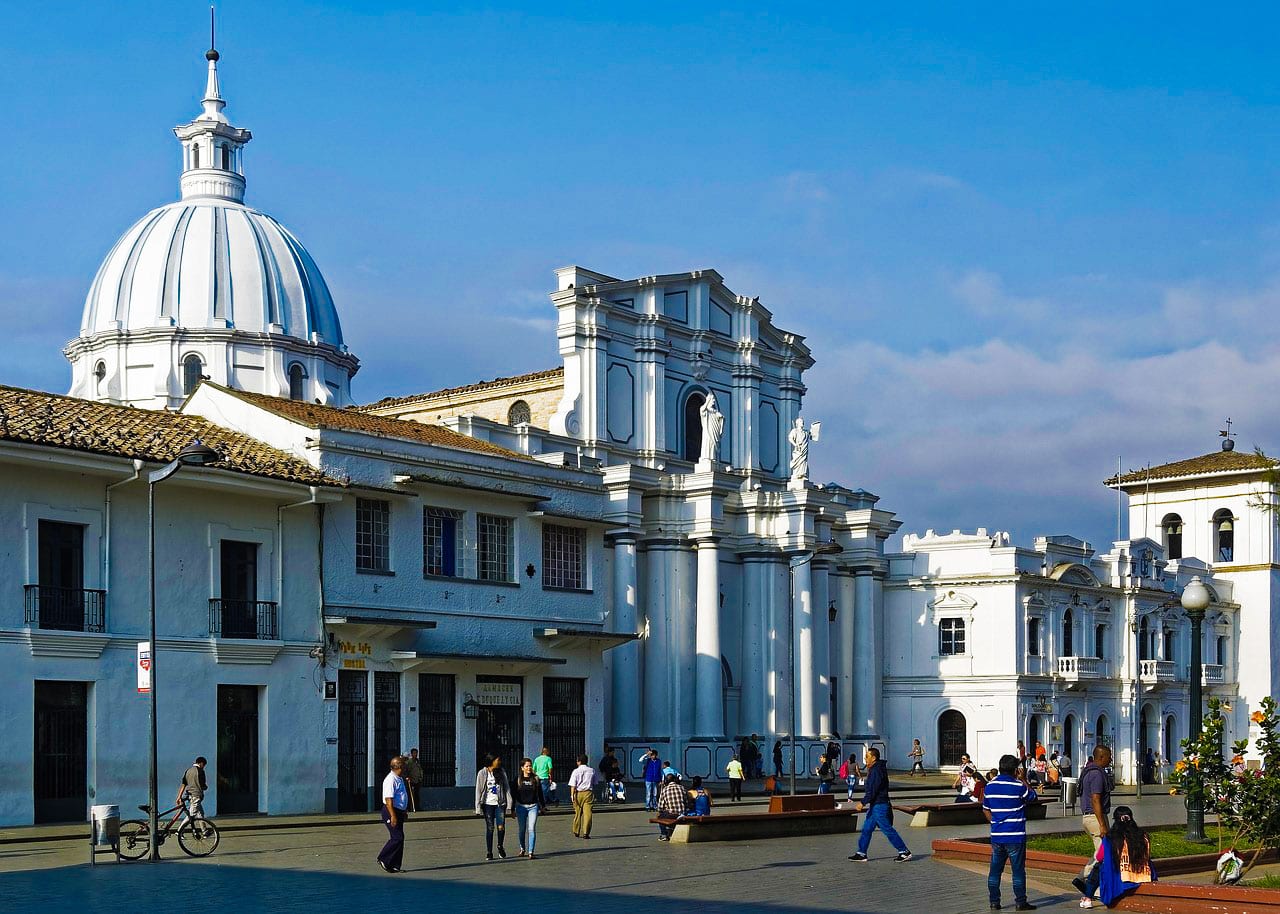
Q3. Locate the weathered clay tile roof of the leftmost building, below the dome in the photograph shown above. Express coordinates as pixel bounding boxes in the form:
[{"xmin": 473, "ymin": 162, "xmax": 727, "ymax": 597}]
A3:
[{"xmin": 0, "ymin": 385, "xmax": 343, "ymax": 486}]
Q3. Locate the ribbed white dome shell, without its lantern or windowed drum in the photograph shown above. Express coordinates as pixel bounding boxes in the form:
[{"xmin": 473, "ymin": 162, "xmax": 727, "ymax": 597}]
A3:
[{"xmin": 81, "ymin": 197, "xmax": 346, "ymax": 351}]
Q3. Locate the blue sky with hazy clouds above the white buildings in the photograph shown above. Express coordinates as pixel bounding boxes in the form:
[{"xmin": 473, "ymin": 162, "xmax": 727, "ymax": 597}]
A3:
[{"xmin": 0, "ymin": 0, "xmax": 1280, "ymax": 545}]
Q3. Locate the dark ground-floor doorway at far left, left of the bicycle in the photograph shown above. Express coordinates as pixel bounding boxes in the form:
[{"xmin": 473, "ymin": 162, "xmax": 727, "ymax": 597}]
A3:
[{"xmin": 33, "ymin": 680, "xmax": 88, "ymax": 823}]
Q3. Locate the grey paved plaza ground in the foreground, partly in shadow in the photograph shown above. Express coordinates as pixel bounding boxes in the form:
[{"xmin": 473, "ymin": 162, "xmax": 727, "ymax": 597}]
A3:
[{"xmin": 0, "ymin": 796, "xmax": 1181, "ymax": 914}]
